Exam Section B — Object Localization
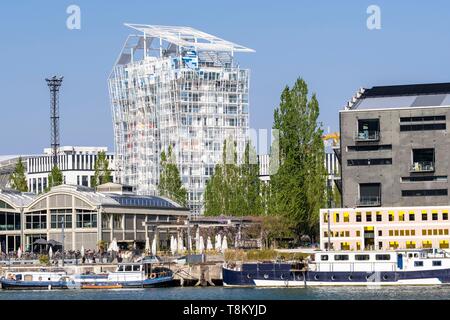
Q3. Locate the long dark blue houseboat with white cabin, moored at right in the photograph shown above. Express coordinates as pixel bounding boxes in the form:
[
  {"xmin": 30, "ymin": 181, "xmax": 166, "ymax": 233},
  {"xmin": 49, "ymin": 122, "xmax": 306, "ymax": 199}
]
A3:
[{"xmin": 223, "ymin": 249, "xmax": 450, "ymax": 287}]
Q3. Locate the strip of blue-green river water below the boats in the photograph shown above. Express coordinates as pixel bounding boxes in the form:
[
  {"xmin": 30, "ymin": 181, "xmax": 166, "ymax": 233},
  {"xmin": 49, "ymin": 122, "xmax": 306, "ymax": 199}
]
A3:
[{"xmin": 0, "ymin": 286, "xmax": 450, "ymax": 300}]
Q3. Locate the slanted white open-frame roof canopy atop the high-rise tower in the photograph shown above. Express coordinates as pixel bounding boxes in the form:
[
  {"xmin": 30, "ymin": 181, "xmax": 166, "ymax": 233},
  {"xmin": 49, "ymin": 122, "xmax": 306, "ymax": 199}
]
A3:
[{"xmin": 125, "ymin": 23, "xmax": 255, "ymax": 52}]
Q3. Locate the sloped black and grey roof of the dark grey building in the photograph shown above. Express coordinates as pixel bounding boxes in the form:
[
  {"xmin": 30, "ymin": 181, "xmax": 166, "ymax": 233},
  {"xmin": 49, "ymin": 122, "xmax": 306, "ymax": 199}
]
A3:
[{"xmin": 345, "ymin": 83, "xmax": 450, "ymax": 110}]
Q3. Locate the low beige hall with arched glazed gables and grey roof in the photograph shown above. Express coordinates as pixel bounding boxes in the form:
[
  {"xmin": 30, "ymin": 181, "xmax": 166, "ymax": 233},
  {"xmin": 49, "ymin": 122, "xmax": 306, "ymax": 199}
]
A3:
[{"xmin": 0, "ymin": 183, "xmax": 189, "ymax": 252}]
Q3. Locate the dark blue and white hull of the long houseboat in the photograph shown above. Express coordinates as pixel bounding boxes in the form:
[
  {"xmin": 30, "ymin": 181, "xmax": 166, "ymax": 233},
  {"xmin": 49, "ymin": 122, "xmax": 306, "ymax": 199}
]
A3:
[{"xmin": 223, "ymin": 268, "xmax": 450, "ymax": 287}]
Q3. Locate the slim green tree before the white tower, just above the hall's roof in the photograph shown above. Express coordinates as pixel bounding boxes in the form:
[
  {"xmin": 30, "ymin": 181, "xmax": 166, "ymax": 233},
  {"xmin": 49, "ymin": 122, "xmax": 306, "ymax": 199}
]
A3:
[{"xmin": 158, "ymin": 146, "xmax": 187, "ymax": 206}]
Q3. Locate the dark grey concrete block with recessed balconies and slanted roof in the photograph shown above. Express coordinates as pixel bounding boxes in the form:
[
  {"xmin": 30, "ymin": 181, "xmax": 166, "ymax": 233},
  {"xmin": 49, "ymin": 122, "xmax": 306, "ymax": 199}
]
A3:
[{"xmin": 339, "ymin": 83, "xmax": 450, "ymax": 208}]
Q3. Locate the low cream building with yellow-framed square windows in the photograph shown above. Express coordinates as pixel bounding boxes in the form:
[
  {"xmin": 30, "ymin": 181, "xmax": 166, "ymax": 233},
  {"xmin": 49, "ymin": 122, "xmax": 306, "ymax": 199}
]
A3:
[{"xmin": 320, "ymin": 206, "xmax": 450, "ymax": 250}]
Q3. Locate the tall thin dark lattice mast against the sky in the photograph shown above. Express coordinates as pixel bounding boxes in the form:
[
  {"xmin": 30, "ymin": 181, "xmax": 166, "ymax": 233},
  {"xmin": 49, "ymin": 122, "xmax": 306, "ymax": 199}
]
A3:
[{"xmin": 45, "ymin": 76, "xmax": 64, "ymax": 166}]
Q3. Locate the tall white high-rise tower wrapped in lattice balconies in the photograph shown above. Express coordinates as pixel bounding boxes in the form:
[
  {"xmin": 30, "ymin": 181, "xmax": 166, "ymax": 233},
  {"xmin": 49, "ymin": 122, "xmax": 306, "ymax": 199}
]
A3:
[{"xmin": 109, "ymin": 24, "xmax": 254, "ymax": 213}]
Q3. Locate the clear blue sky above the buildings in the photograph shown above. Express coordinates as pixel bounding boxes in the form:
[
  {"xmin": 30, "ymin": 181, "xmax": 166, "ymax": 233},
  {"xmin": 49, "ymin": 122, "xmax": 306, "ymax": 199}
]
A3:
[{"xmin": 0, "ymin": 0, "xmax": 450, "ymax": 155}]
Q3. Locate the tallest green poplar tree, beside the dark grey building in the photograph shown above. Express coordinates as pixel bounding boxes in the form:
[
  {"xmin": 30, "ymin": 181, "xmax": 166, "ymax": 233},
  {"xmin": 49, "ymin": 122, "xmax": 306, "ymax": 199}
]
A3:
[{"xmin": 270, "ymin": 79, "xmax": 326, "ymax": 237}]
